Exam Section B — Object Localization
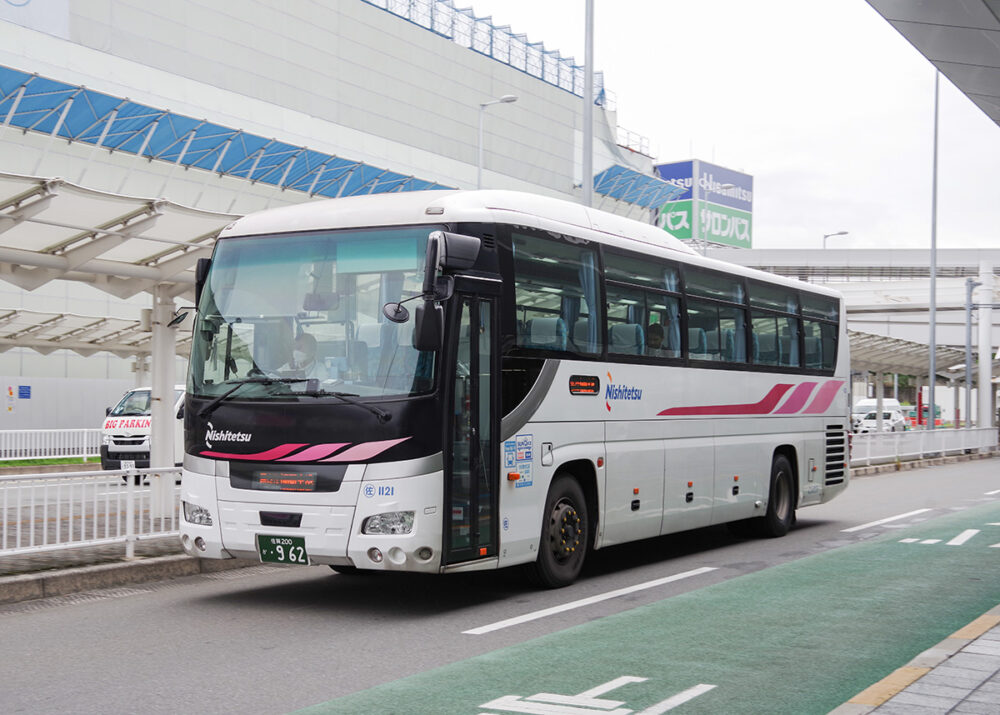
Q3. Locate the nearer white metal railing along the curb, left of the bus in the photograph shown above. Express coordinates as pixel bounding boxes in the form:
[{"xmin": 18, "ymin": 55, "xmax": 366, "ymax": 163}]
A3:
[{"xmin": 0, "ymin": 467, "xmax": 181, "ymax": 558}]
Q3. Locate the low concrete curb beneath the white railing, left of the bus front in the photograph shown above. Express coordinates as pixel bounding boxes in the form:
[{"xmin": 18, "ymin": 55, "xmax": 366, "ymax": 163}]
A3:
[{"xmin": 0, "ymin": 554, "xmax": 260, "ymax": 604}]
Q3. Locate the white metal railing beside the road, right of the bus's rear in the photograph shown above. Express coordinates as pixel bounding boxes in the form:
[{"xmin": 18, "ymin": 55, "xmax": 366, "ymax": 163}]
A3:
[{"xmin": 851, "ymin": 427, "xmax": 997, "ymax": 467}]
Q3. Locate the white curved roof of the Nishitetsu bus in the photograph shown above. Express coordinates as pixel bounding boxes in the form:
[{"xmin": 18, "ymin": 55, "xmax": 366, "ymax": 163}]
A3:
[{"xmin": 219, "ymin": 189, "xmax": 839, "ymax": 297}]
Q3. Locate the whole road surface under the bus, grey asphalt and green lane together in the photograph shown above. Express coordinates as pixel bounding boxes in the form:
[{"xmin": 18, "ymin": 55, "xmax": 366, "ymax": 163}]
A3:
[{"xmin": 0, "ymin": 460, "xmax": 1000, "ymax": 715}]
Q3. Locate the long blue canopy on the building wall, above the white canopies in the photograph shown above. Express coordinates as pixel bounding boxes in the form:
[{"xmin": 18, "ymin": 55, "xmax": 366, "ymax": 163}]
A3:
[{"xmin": 0, "ymin": 66, "xmax": 452, "ymax": 197}]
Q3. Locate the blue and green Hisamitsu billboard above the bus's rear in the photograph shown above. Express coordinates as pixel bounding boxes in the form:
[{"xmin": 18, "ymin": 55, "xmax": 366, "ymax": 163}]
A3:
[{"xmin": 656, "ymin": 159, "xmax": 753, "ymax": 248}]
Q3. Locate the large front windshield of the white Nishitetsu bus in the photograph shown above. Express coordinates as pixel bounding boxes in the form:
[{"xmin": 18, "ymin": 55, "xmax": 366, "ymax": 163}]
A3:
[{"xmin": 188, "ymin": 226, "xmax": 439, "ymax": 400}]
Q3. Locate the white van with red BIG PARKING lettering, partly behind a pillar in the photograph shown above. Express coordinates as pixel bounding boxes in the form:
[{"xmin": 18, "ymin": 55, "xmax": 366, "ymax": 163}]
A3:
[{"xmin": 101, "ymin": 385, "xmax": 184, "ymax": 469}]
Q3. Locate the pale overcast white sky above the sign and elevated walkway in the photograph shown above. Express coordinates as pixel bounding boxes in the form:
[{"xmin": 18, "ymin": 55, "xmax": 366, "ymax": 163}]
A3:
[{"xmin": 464, "ymin": 0, "xmax": 1000, "ymax": 248}]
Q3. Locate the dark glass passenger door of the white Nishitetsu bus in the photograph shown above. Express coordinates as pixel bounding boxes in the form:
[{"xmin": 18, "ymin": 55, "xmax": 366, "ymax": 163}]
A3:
[{"xmin": 444, "ymin": 293, "xmax": 500, "ymax": 564}]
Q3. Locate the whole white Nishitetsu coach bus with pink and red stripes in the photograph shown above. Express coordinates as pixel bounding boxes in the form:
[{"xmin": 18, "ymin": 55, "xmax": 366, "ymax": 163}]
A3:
[{"xmin": 181, "ymin": 191, "xmax": 849, "ymax": 587}]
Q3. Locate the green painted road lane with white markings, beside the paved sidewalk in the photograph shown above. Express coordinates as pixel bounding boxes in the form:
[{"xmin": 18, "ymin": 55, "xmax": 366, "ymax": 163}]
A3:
[{"xmin": 302, "ymin": 502, "xmax": 1000, "ymax": 715}]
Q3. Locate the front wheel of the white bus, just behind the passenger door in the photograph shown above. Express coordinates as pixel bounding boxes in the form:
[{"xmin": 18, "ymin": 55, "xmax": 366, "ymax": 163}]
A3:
[{"xmin": 535, "ymin": 474, "xmax": 590, "ymax": 588}]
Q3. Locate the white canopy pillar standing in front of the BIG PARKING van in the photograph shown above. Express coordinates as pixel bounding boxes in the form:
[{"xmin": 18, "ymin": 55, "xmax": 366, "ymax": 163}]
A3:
[{"xmin": 149, "ymin": 284, "xmax": 176, "ymax": 519}]
